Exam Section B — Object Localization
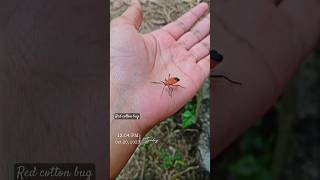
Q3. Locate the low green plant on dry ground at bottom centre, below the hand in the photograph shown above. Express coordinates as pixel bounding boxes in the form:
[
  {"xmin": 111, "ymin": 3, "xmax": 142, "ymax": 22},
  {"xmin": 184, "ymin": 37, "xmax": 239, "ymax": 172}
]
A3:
[{"xmin": 160, "ymin": 150, "xmax": 186, "ymax": 169}]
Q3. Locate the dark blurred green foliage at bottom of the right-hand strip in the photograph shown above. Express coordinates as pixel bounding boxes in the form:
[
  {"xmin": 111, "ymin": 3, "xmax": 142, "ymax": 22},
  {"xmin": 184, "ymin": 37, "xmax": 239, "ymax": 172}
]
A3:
[{"xmin": 229, "ymin": 120, "xmax": 273, "ymax": 180}]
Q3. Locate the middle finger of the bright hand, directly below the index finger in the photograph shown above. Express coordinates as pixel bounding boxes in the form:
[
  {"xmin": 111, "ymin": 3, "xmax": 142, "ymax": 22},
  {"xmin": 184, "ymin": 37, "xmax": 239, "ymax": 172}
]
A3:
[{"xmin": 178, "ymin": 14, "xmax": 210, "ymax": 50}]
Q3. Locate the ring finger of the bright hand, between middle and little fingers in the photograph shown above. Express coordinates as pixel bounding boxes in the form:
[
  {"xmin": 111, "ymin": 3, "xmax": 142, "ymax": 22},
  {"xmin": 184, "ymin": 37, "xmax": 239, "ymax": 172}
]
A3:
[{"xmin": 189, "ymin": 35, "xmax": 210, "ymax": 62}]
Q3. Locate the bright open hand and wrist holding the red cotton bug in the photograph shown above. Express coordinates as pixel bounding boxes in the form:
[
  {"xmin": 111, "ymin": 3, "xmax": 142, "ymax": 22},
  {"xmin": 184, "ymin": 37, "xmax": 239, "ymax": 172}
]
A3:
[{"xmin": 110, "ymin": 0, "xmax": 210, "ymax": 178}]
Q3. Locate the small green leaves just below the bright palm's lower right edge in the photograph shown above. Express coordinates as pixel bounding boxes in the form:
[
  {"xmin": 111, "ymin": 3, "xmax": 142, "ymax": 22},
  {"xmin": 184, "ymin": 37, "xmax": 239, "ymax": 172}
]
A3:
[{"xmin": 182, "ymin": 101, "xmax": 197, "ymax": 128}]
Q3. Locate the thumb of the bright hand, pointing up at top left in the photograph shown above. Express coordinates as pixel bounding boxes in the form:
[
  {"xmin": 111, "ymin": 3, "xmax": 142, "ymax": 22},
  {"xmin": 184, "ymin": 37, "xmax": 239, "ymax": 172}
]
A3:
[{"xmin": 121, "ymin": 0, "xmax": 143, "ymax": 30}]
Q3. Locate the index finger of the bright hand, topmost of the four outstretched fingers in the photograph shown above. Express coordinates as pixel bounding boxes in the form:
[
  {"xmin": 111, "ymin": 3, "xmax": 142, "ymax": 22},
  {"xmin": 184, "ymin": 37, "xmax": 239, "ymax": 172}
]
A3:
[{"xmin": 162, "ymin": 3, "xmax": 208, "ymax": 39}]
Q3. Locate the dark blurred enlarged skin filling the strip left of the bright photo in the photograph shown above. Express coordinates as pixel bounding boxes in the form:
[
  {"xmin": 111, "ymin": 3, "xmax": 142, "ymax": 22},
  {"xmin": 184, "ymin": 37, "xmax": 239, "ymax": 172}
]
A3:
[{"xmin": 0, "ymin": 0, "xmax": 109, "ymax": 180}]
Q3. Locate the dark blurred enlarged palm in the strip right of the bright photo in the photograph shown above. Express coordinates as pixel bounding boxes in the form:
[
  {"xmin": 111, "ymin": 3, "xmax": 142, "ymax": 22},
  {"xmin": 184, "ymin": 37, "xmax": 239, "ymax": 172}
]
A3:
[{"xmin": 211, "ymin": 0, "xmax": 320, "ymax": 157}]
